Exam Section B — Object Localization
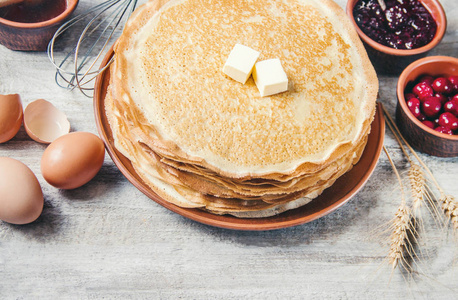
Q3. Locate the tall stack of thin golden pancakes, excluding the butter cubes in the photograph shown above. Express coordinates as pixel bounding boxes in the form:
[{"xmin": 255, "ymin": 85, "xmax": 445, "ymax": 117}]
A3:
[{"xmin": 105, "ymin": 0, "xmax": 378, "ymax": 217}]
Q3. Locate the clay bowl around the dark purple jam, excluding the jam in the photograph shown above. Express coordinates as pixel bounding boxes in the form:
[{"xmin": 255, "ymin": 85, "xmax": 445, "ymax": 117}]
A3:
[{"xmin": 346, "ymin": 0, "xmax": 447, "ymax": 75}]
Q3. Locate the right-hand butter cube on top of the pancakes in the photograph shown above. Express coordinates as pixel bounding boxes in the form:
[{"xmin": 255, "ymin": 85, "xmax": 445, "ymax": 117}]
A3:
[{"xmin": 253, "ymin": 58, "xmax": 288, "ymax": 97}]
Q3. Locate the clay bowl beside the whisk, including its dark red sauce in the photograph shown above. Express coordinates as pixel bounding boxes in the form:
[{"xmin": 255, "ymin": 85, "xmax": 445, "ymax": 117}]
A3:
[{"xmin": 0, "ymin": 0, "xmax": 78, "ymax": 51}]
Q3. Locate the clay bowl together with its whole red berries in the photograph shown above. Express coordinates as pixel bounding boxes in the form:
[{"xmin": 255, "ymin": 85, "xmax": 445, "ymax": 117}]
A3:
[{"xmin": 396, "ymin": 56, "xmax": 458, "ymax": 157}]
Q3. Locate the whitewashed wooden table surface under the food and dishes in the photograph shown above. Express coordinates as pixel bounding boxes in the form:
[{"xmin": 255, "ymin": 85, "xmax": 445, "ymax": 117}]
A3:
[{"xmin": 0, "ymin": 0, "xmax": 458, "ymax": 299}]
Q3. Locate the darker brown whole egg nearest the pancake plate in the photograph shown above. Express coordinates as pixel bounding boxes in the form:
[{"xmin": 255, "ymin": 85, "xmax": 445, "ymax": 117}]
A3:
[{"xmin": 41, "ymin": 132, "xmax": 105, "ymax": 189}]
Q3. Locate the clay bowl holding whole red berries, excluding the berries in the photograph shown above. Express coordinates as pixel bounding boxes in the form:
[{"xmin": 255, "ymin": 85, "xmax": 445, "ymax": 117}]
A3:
[{"xmin": 396, "ymin": 56, "xmax": 458, "ymax": 157}]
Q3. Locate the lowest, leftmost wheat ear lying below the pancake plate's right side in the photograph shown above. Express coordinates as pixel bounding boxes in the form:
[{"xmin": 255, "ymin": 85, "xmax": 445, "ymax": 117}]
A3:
[{"xmin": 388, "ymin": 203, "xmax": 416, "ymax": 271}]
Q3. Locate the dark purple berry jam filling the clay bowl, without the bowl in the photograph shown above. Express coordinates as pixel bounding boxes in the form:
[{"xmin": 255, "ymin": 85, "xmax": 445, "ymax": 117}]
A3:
[{"xmin": 353, "ymin": 0, "xmax": 437, "ymax": 49}]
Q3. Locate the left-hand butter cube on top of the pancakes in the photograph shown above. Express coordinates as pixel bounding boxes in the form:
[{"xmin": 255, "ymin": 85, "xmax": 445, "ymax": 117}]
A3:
[{"xmin": 223, "ymin": 44, "xmax": 259, "ymax": 83}]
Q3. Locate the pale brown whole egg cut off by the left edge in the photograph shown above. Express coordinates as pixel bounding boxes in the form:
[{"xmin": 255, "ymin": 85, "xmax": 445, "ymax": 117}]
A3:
[{"xmin": 0, "ymin": 157, "xmax": 44, "ymax": 224}]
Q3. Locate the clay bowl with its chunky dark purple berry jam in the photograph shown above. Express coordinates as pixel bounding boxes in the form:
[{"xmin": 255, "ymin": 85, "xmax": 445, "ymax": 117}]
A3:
[{"xmin": 346, "ymin": 0, "xmax": 447, "ymax": 75}]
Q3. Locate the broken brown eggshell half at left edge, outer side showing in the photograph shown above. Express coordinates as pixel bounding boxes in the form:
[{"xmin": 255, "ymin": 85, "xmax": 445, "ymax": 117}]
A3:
[{"xmin": 0, "ymin": 94, "xmax": 23, "ymax": 143}]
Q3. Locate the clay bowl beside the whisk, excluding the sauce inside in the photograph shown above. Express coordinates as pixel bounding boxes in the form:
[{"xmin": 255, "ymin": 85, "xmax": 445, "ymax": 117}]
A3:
[{"xmin": 0, "ymin": 0, "xmax": 78, "ymax": 51}]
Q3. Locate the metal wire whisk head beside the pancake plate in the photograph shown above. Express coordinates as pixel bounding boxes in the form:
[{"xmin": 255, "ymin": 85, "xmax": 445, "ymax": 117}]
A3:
[{"xmin": 48, "ymin": 0, "xmax": 137, "ymax": 98}]
